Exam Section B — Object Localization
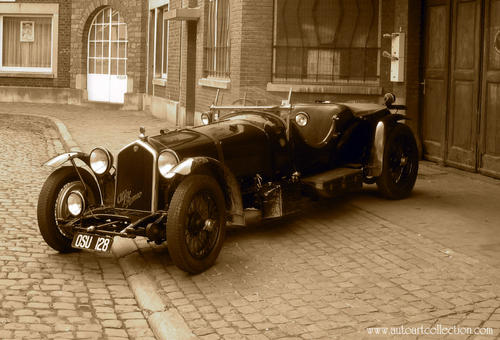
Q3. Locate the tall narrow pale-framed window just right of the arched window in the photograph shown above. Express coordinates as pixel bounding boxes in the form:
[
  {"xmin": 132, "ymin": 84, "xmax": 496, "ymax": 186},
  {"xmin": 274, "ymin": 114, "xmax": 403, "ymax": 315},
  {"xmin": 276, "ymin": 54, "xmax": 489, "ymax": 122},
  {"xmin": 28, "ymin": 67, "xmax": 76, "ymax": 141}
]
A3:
[{"xmin": 153, "ymin": 3, "xmax": 170, "ymax": 79}]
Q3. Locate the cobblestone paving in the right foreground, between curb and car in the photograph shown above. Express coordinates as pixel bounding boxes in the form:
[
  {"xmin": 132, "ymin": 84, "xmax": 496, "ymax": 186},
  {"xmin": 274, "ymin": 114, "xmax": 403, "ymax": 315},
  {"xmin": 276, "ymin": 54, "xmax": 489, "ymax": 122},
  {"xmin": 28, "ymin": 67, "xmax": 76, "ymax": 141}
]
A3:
[{"xmin": 135, "ymin": 197, "xmax": 500, "ymax": 339}]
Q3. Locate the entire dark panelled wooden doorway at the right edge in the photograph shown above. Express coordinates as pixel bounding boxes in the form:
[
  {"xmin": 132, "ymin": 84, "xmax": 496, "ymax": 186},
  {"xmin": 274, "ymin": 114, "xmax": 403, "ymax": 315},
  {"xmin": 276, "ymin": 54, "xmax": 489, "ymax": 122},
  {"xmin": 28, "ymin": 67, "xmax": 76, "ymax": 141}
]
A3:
[{"xmin": 421, "ymin": 0, "xmax": 500, "ymax": 177}]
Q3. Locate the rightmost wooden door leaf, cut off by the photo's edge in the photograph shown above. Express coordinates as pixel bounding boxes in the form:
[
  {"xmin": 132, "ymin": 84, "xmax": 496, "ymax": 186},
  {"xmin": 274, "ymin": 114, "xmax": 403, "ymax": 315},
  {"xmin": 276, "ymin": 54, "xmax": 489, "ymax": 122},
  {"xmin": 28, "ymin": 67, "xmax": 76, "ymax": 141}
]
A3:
[{"xmin": 479, "ymin": 0, "xmax": 500, "ymax": 178}]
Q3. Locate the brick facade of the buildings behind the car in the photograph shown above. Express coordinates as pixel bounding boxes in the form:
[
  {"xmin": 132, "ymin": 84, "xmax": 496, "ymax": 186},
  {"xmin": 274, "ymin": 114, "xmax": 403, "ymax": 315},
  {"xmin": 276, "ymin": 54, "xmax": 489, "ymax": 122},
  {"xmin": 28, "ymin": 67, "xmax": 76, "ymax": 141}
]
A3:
[{"xmin": 0, "ymin": 0, "xmax": 423, "ymax": 121}]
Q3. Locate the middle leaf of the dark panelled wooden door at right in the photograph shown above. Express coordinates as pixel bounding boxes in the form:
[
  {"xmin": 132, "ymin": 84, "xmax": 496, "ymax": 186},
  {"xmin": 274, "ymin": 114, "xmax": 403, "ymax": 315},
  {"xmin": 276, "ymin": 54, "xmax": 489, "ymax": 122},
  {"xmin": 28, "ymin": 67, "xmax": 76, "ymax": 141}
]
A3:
[{"xmin": 445, "ymin": 0, "xmax": 481, "ymax": 171}]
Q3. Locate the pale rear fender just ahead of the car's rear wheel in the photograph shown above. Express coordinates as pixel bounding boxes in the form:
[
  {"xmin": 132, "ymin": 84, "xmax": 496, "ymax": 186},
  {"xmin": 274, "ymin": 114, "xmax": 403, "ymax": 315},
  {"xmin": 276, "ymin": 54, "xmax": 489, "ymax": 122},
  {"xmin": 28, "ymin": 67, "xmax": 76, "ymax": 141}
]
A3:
[{"xmin": 366, "ymin": 113, "xmax": 409, "ymax": 177}]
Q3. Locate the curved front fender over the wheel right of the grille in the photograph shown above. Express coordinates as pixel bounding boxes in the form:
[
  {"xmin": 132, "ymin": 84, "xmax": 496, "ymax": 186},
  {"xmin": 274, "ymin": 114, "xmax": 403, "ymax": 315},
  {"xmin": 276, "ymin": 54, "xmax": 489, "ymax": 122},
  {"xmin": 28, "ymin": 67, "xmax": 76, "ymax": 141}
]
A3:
[{"xmin": 165, "ymin": 157, "xmax": 245, "ymax": 225}]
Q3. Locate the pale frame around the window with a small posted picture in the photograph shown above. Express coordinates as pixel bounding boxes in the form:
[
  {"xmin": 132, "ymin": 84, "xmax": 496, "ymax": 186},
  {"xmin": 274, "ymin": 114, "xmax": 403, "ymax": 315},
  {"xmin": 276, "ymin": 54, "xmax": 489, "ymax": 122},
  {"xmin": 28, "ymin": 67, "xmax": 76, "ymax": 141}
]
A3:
[{"xmin": 0, "ymin": 3, "xmax": 59, "ymax": 78}]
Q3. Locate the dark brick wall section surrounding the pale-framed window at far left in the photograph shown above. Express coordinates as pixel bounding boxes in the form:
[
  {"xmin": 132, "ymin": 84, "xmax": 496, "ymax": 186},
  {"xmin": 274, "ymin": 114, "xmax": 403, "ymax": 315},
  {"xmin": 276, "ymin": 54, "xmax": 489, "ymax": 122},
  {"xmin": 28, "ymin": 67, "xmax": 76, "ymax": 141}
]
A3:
[{"xmin": 0, "ymin": 0, "xmax": 71, "ymax": 87}]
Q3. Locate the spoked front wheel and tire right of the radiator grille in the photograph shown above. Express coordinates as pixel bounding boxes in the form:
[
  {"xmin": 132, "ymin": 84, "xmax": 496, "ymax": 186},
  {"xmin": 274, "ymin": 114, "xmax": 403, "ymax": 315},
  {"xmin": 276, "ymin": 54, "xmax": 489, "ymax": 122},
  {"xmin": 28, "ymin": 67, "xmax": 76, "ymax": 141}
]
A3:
[{"xmin": 167, "ymin": 175, "xmax": 226, "ymax": 274}]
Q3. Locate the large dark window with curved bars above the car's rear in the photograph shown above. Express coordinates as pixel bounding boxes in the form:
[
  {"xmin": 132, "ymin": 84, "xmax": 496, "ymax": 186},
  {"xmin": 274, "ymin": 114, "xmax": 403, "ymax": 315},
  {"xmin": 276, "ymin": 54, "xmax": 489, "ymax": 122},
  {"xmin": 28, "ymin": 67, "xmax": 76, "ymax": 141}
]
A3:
[{"xmin": 273, "ymin": 0, "xmax": 380, "ymax": 84}]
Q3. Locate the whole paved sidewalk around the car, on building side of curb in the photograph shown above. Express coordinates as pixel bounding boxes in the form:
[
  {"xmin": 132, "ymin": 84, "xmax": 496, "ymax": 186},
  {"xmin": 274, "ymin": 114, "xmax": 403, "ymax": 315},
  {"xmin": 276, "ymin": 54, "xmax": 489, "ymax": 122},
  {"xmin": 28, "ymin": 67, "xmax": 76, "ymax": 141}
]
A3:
[{"xmin": 5, "ymin": 104, "xmax": 500, "ymax": 339}]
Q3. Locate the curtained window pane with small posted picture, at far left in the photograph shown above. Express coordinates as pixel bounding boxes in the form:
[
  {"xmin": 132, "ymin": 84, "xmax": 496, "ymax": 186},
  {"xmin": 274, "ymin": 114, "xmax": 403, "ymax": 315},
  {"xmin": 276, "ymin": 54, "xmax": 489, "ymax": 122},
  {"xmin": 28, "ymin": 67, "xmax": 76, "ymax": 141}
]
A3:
[{"xmin": 0, "ymin": 15, "xmax": 53, "ymax": 72}]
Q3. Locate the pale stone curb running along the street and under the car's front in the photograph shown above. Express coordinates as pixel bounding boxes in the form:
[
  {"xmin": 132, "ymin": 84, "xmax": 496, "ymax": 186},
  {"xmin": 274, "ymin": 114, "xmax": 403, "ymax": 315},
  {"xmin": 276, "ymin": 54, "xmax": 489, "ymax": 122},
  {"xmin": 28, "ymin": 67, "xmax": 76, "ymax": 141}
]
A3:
[{"xmin": 0, "ymin": 113, "xmax": 196, "ymax": 340}]
